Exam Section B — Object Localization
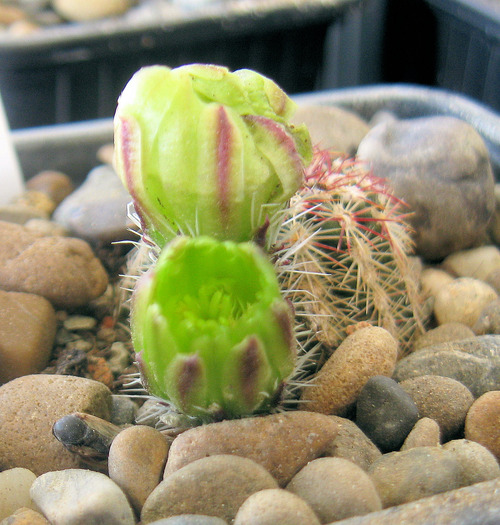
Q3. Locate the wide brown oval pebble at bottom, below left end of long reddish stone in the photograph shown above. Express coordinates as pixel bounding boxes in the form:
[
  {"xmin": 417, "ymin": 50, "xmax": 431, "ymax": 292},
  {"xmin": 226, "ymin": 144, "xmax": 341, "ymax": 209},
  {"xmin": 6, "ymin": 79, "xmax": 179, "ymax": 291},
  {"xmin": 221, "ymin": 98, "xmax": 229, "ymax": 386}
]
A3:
[{"xmin": 141, "ymin": 452, "xmax": 278, "ymax": 524}]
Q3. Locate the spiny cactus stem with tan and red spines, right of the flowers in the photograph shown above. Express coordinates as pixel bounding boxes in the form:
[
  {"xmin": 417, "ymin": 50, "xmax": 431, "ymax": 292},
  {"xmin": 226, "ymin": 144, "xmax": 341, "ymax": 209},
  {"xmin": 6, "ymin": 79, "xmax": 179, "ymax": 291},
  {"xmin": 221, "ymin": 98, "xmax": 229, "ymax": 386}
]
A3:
[{"xmin": 275, "ymin": 150, "xmax": 424, "ymax": 402}]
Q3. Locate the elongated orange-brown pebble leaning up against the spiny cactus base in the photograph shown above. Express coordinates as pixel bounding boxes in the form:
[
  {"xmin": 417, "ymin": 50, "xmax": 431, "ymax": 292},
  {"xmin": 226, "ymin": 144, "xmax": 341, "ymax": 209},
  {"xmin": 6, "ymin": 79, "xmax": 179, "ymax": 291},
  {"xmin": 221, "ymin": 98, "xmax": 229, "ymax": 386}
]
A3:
[{"xmin": 301, "ymin": 326, "xmax": 398, "ymax": 416}]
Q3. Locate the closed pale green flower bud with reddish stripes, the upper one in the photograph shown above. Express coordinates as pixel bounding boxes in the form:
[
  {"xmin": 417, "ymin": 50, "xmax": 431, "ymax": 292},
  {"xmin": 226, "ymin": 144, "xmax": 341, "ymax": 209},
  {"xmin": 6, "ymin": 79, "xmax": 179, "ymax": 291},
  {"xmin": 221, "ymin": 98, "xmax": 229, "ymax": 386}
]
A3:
[{"xmin": 115, "ymin": 64, "xmax": 312, "ymax": 247}]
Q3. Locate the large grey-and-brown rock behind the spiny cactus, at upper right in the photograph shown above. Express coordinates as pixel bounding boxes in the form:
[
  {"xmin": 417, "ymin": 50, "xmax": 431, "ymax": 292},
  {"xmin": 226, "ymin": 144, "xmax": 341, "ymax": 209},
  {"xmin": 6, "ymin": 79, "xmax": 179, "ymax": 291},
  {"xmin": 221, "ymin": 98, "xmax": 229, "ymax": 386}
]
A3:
[{"xmin": 358, "ymin": 116, "xmax": 495, "ymax": 260}]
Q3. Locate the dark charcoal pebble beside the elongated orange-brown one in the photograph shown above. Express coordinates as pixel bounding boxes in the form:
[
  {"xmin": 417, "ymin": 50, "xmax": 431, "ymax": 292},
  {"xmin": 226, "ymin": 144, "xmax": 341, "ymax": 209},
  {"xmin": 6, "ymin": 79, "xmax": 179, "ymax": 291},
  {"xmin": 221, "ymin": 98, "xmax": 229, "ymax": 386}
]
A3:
[{"xmin": 356, "ymin": 376, "xmax": 419, "ymax": 452}]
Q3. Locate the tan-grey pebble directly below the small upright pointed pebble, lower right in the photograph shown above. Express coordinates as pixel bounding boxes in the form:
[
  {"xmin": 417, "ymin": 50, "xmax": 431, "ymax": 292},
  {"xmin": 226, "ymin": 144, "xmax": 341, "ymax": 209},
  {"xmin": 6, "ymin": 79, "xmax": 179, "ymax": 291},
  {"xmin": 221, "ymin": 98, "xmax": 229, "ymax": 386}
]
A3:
[{"xmin": 368, "ymin": 447, "xmax": 462, "ymax": 508}]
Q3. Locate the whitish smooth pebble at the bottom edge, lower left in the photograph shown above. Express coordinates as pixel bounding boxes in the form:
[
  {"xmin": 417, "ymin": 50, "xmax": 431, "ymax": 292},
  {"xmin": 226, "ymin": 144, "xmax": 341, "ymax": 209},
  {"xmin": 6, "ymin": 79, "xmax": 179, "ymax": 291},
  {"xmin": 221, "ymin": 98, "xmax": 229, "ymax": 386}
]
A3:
[{"xmin": 31, "ymin": 469, "xmax": 135, "ymax": 525}]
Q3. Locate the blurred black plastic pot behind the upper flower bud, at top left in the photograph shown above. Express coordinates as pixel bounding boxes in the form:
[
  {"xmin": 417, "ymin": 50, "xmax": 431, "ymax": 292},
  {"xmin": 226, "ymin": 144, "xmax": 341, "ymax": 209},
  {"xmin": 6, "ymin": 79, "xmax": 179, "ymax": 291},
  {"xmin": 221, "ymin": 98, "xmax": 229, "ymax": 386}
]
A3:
[{"xmin": 0, "ymin": 0, "xmax": 386, "ymax": 129}]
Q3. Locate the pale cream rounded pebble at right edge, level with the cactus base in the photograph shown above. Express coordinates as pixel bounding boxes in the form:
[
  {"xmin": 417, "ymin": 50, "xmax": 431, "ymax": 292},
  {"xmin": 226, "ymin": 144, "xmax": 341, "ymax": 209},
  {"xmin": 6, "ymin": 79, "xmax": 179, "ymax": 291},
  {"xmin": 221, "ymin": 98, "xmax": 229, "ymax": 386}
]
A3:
[{"xmin": 434, "ymin": 277, "xmax": 498, "ymax": 328}]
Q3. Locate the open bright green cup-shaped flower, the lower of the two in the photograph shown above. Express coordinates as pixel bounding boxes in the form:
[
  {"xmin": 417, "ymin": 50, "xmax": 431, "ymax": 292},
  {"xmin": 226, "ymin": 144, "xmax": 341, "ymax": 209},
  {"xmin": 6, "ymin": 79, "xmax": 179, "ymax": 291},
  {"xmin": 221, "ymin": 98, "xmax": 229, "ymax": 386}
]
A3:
[{"xmin": 130, "ymin": 236, "xmax": 295, "ymax": 419}]
